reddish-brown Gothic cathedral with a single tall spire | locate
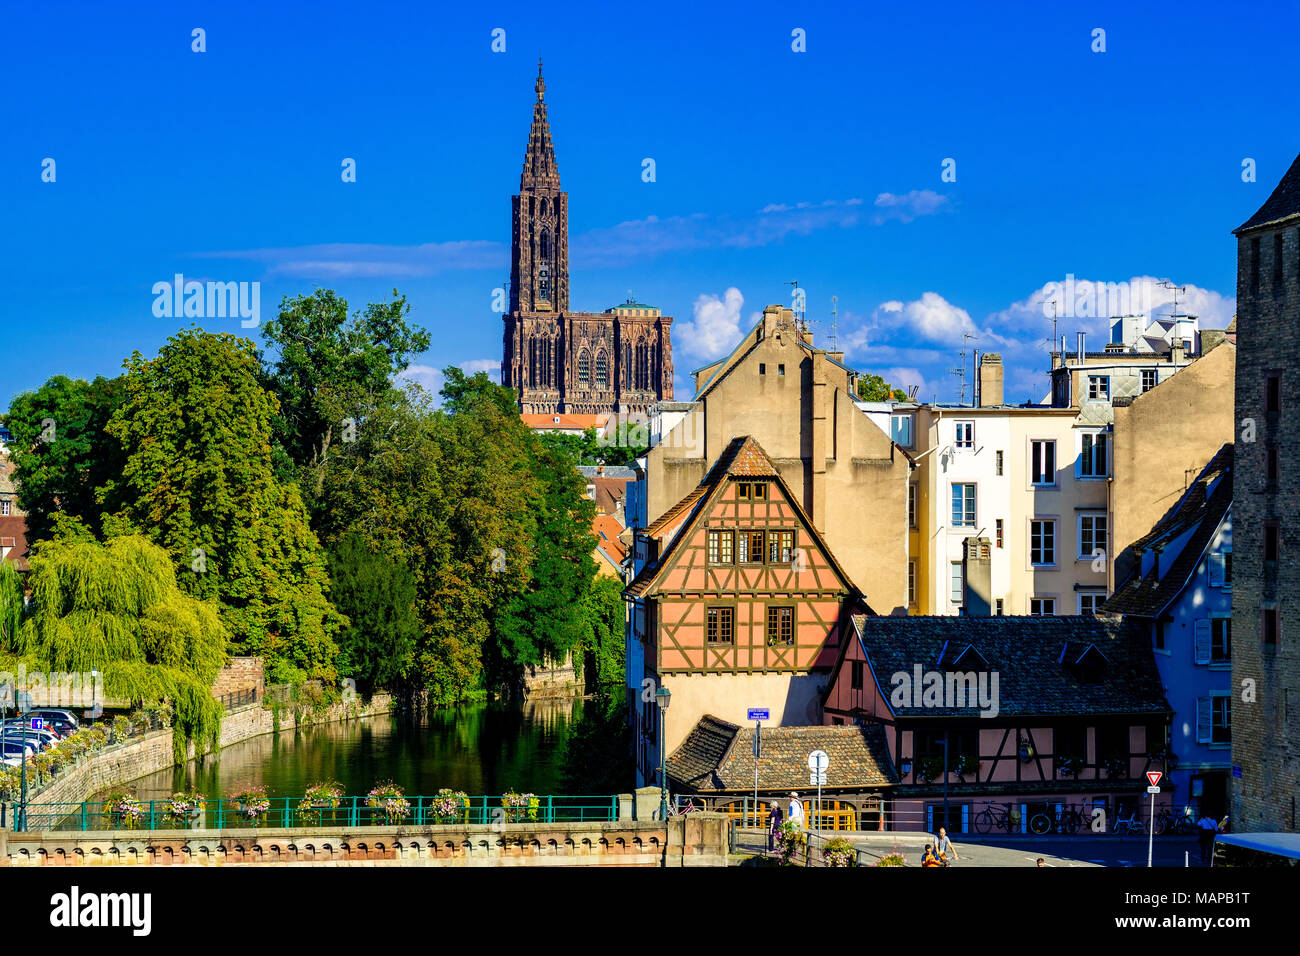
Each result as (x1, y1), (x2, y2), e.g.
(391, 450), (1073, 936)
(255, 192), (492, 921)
(501, 64), (672, 416)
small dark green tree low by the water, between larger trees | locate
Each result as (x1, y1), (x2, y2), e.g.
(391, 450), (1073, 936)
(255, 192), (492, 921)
(329, 532), (420, 696)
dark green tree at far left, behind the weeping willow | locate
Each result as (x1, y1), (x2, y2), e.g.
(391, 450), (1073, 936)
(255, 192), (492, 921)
(5, 375), (124, 544)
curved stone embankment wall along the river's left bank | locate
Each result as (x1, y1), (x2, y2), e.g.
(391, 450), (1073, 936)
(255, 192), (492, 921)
(29, 695), (391, 804)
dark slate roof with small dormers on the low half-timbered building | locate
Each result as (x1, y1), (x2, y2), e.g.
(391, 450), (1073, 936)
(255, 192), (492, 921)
(841, 615), (1170, 718)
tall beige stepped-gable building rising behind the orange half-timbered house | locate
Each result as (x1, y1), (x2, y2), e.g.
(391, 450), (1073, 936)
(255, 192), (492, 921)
(629, 306), (910, 614)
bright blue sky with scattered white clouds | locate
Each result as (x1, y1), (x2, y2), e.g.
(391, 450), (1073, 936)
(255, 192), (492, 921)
(0, 1), (1300, 407)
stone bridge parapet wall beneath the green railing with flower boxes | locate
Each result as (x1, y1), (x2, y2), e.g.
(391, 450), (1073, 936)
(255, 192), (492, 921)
(0, 813), (729, 868)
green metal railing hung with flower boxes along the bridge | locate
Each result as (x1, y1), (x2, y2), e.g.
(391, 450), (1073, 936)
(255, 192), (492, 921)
(10, 795), (619, 831)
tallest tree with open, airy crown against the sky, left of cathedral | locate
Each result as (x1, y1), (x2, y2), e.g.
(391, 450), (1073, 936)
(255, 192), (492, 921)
(263, 289), (429, 499)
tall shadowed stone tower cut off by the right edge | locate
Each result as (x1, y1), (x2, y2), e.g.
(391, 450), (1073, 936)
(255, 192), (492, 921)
(1231, 156), (1300, 831)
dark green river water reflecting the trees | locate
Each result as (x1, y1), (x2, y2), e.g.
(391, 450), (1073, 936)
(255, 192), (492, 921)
(116, 698), (582, 800)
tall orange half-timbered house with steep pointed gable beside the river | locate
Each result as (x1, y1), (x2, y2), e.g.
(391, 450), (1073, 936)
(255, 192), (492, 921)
(624, 437), (862, 782)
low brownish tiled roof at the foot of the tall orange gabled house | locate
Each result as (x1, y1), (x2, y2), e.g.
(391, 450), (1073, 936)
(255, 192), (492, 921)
(668, 714), (898, 793)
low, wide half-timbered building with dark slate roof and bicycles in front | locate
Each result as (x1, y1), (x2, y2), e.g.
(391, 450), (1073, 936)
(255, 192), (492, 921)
(824, 615), (1180, 832)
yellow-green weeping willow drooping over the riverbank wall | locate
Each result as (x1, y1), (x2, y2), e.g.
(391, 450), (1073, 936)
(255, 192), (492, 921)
(0, 535), (228, 762)
